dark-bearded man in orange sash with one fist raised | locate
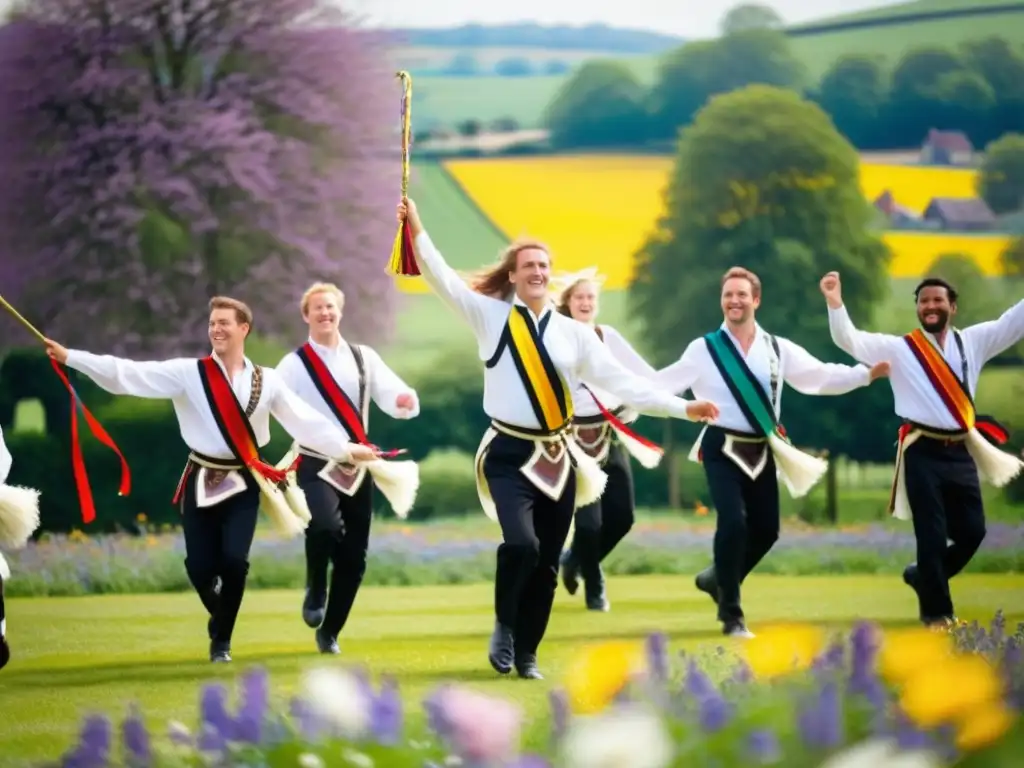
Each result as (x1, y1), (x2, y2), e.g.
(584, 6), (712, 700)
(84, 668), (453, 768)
(821, 272), (1024, 627)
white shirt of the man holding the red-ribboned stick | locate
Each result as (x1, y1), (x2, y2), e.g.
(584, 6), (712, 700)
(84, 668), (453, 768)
(67, 349), (349, 461)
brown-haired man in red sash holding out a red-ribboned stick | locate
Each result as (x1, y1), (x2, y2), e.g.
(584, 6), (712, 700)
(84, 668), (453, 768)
(47, 296), (376, 663)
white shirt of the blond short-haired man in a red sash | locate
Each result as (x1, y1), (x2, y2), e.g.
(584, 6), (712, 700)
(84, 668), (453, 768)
(276, 339), (420, 437)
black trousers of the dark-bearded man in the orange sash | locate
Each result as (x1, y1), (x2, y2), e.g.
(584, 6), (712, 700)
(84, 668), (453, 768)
(903, 436), (985, 621)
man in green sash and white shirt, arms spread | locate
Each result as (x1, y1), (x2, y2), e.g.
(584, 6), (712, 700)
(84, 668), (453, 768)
(657, 267), (888, 638)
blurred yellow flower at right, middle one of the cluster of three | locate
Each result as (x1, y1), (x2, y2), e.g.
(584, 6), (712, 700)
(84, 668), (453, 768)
(900, 655), (1002, 728)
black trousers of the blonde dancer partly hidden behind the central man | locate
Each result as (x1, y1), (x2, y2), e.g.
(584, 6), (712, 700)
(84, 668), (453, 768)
(572, 439), (635, 585)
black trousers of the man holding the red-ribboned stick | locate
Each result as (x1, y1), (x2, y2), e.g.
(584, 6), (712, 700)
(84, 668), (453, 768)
(181, 467), (259, 646)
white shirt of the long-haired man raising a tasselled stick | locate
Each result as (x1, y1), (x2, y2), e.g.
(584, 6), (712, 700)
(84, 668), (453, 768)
(416, 231), (688, 429)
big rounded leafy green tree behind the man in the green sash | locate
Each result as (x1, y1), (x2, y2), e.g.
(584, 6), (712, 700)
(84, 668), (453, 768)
(630, 85), (892, 460)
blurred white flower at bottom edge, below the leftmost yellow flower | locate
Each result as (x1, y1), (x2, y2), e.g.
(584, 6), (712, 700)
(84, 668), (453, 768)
(562, 706), (673, 768)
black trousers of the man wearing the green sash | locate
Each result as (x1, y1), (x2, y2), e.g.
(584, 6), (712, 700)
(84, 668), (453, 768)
(700, 427), (779, 622)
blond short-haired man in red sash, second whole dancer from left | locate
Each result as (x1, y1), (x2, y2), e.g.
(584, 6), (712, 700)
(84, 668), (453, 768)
(278, 283), (420, 653)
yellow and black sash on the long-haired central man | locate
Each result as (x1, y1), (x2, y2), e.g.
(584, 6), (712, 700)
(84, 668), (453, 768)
(485, 304), (572, 432)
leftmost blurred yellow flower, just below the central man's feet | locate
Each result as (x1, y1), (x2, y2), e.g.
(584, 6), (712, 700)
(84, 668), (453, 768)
(565, 640), (644, 715)
